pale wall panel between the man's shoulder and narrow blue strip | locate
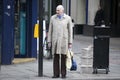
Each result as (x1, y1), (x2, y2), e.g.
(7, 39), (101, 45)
(71, 0), (86, 24)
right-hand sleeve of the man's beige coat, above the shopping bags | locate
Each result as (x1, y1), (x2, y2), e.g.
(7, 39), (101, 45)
(68, 17), (73, 43)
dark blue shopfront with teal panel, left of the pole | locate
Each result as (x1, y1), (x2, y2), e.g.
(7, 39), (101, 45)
(0, 0), (37, 64)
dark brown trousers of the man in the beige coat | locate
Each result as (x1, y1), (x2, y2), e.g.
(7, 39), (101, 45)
(53, 54), (66, 76)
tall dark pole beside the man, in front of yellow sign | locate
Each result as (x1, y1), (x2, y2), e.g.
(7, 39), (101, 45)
(38, 0), (44, 77)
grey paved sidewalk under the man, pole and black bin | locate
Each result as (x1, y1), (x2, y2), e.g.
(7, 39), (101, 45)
(0, 35), (120, 80)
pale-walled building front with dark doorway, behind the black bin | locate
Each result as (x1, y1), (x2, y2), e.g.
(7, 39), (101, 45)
(71, 0), (120, 37)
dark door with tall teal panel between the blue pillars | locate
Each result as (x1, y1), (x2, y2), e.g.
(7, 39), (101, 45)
(14, 0), (27, 57)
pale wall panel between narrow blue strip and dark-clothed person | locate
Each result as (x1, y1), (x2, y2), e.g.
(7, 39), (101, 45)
(88, 0), (99, 25)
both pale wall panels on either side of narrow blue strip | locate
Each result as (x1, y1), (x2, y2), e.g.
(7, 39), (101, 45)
(71, 0), (100, 25)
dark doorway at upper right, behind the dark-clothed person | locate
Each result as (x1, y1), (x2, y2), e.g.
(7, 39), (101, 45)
(100, 0), (120, 37)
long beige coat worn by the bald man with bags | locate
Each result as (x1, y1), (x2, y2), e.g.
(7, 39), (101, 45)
(48, 14), (73, 54)
